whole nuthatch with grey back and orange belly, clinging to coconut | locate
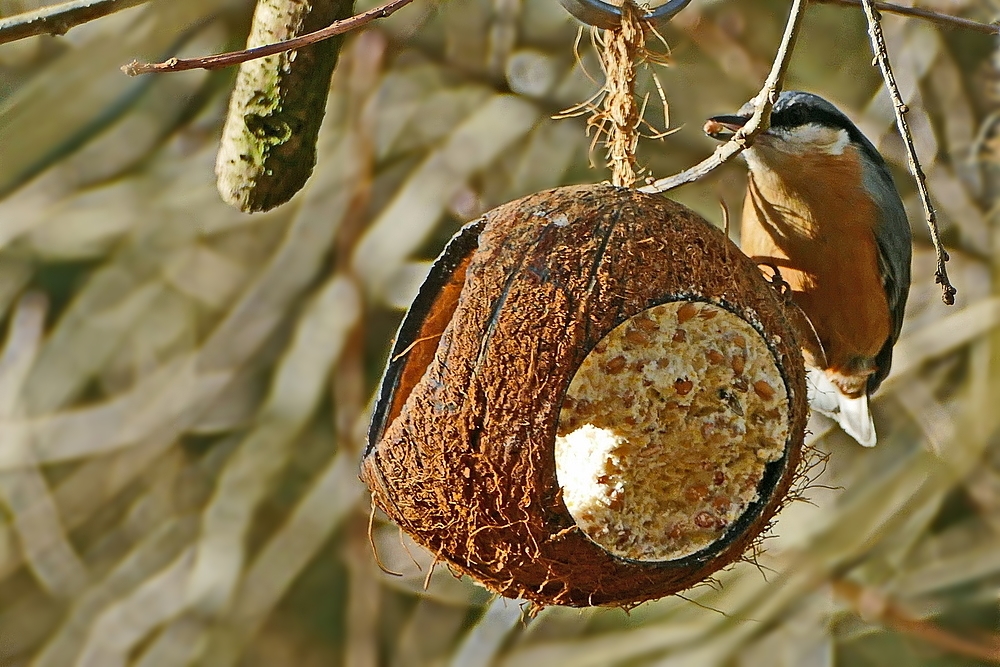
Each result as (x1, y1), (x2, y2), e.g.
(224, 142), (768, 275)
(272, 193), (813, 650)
(705, 91), (911, 447)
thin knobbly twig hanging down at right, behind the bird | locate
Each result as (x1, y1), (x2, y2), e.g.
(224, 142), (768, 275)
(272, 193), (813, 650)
(861, 0), (957, 306)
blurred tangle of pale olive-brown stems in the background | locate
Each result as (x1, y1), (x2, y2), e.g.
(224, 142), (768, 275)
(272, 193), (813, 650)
(0, 0), (1000, 667)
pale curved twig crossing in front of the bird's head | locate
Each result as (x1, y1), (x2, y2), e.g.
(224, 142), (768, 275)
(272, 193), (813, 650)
(639, 0), (808, 192)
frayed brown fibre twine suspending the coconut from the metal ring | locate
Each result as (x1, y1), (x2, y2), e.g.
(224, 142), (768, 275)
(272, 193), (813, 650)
(601, 0), (645, 188)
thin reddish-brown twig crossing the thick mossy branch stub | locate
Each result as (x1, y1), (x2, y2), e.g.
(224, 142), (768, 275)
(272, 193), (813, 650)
(122, 0), (412, 76)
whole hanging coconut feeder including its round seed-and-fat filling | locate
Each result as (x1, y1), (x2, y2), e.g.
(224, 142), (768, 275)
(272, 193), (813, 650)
(361, 184), (808, 606)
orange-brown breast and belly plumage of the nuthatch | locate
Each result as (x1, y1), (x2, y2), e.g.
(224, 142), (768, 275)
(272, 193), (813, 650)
(740, 147), (891, 396)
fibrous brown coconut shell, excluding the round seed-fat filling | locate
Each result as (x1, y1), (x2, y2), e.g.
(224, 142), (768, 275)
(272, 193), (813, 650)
(361, 185), (808, 606)
